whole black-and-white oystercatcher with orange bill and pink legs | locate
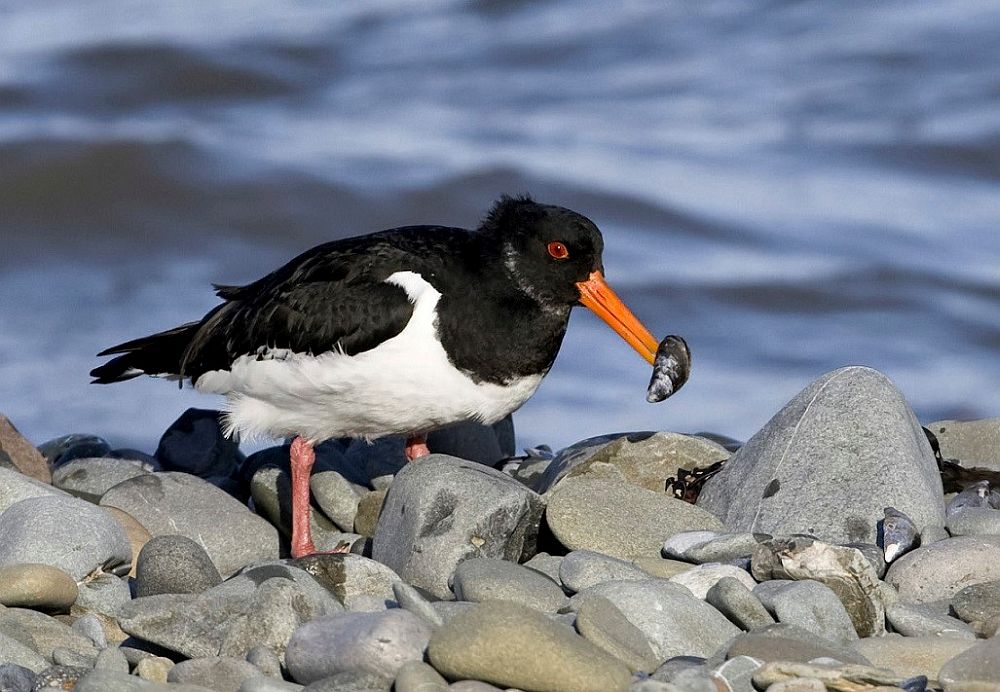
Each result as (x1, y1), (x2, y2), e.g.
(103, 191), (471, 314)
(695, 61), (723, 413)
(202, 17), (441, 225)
(91, 196), (657, 557)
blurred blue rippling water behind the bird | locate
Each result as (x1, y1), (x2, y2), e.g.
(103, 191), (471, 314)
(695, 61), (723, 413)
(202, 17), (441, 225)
(0, 0), (1000, 449)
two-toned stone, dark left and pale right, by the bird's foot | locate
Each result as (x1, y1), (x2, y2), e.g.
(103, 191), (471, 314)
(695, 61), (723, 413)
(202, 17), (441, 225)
(289, 553), (402, 610)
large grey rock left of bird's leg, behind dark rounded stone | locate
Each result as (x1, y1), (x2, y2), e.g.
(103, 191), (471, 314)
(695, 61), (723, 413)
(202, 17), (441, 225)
(101, 472), (279, 577)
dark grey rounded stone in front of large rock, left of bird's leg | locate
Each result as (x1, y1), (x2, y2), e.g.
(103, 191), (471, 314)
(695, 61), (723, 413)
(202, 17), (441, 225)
(135, 535), (222, 597)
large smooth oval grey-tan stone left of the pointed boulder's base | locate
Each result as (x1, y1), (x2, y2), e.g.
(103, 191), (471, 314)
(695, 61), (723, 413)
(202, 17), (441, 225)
(545, 476), (723, 560)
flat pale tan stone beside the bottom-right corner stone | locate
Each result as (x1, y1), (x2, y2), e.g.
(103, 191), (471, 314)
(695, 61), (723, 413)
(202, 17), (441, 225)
(851, 634), (975, 680)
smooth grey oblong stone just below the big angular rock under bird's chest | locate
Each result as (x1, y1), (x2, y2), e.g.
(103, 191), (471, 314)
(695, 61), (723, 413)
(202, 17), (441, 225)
(452, 557), (566, 613)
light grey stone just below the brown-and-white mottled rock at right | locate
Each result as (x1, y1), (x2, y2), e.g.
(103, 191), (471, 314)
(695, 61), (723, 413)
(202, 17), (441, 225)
(755, 580), (858, 644)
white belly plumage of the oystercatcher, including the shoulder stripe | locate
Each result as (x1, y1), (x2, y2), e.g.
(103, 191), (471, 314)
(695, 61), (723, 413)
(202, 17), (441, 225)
(196, 271), (542, 442)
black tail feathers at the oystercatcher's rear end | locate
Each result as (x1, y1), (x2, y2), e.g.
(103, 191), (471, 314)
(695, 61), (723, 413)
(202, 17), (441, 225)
(90, 322), (200, 384)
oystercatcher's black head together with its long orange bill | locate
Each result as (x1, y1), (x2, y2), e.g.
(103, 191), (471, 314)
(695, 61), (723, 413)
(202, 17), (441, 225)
(480, 196), (658, 364)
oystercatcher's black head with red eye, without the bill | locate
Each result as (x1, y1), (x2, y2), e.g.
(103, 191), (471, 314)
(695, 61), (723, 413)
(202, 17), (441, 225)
(483, 196), (604, 310)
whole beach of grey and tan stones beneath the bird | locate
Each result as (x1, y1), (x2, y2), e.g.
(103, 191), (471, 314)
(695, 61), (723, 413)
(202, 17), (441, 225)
(0, 367), (1000, 692)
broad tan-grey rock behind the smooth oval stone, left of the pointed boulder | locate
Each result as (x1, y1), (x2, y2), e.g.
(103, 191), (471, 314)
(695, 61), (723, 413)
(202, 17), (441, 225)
(535, 432), (729, 492)
